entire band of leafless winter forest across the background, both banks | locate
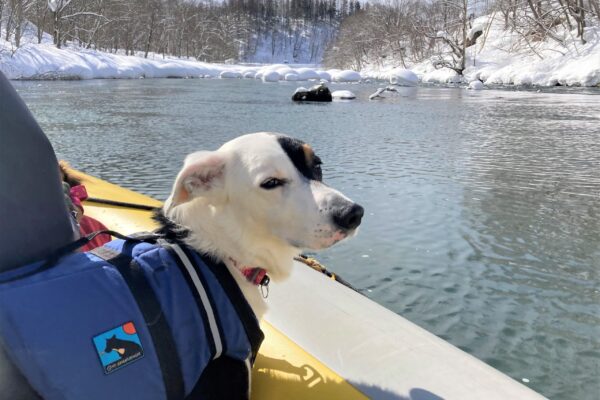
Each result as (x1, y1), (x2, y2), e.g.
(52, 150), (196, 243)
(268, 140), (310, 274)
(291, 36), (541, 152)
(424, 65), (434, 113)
(0, 0), (600, 74)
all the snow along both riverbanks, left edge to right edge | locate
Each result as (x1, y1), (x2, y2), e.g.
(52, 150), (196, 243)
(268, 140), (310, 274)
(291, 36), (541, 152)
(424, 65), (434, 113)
(0, 16), (600, 86)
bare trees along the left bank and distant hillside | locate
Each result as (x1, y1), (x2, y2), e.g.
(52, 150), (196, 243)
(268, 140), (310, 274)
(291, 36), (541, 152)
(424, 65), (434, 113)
(0, 0), (360, 62)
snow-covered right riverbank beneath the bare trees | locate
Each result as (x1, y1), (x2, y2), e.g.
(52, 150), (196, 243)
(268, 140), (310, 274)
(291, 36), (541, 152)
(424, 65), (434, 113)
(363, 14), (600, 86)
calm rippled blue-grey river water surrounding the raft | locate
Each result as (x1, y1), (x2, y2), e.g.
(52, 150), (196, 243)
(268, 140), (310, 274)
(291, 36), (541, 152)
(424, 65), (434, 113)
(10, 80), (600, 400)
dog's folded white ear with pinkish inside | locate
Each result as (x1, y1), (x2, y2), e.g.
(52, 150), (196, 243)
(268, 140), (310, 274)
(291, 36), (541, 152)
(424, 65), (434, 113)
(165, 151), (225, 209)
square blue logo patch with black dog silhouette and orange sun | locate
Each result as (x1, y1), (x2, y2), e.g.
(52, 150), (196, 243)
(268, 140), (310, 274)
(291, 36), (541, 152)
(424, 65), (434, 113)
(93, 322), (144, 374)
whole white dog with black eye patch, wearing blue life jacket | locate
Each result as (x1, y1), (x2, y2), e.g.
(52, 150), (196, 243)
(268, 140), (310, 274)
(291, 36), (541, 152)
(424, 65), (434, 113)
(0, 132), (364, 400)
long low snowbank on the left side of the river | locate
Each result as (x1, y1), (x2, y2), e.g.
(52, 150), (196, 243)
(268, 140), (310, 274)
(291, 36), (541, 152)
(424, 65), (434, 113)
(0, 40), (361, 82)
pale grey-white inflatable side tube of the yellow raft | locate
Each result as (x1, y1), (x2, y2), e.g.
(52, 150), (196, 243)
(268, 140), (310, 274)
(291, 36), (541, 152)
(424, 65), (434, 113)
(264, 261), (545, 400)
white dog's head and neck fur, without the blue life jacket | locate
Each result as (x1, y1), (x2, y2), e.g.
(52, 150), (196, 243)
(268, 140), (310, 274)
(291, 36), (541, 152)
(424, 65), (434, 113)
(162, 132), (364, 319)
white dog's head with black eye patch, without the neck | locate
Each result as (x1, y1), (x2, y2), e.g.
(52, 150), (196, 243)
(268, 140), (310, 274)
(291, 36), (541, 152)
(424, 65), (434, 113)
(165, 132), (363, 276)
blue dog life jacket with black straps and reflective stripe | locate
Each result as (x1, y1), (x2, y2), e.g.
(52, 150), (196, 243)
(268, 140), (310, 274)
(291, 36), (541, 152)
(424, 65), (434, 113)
(0, 234), (264, 400)
